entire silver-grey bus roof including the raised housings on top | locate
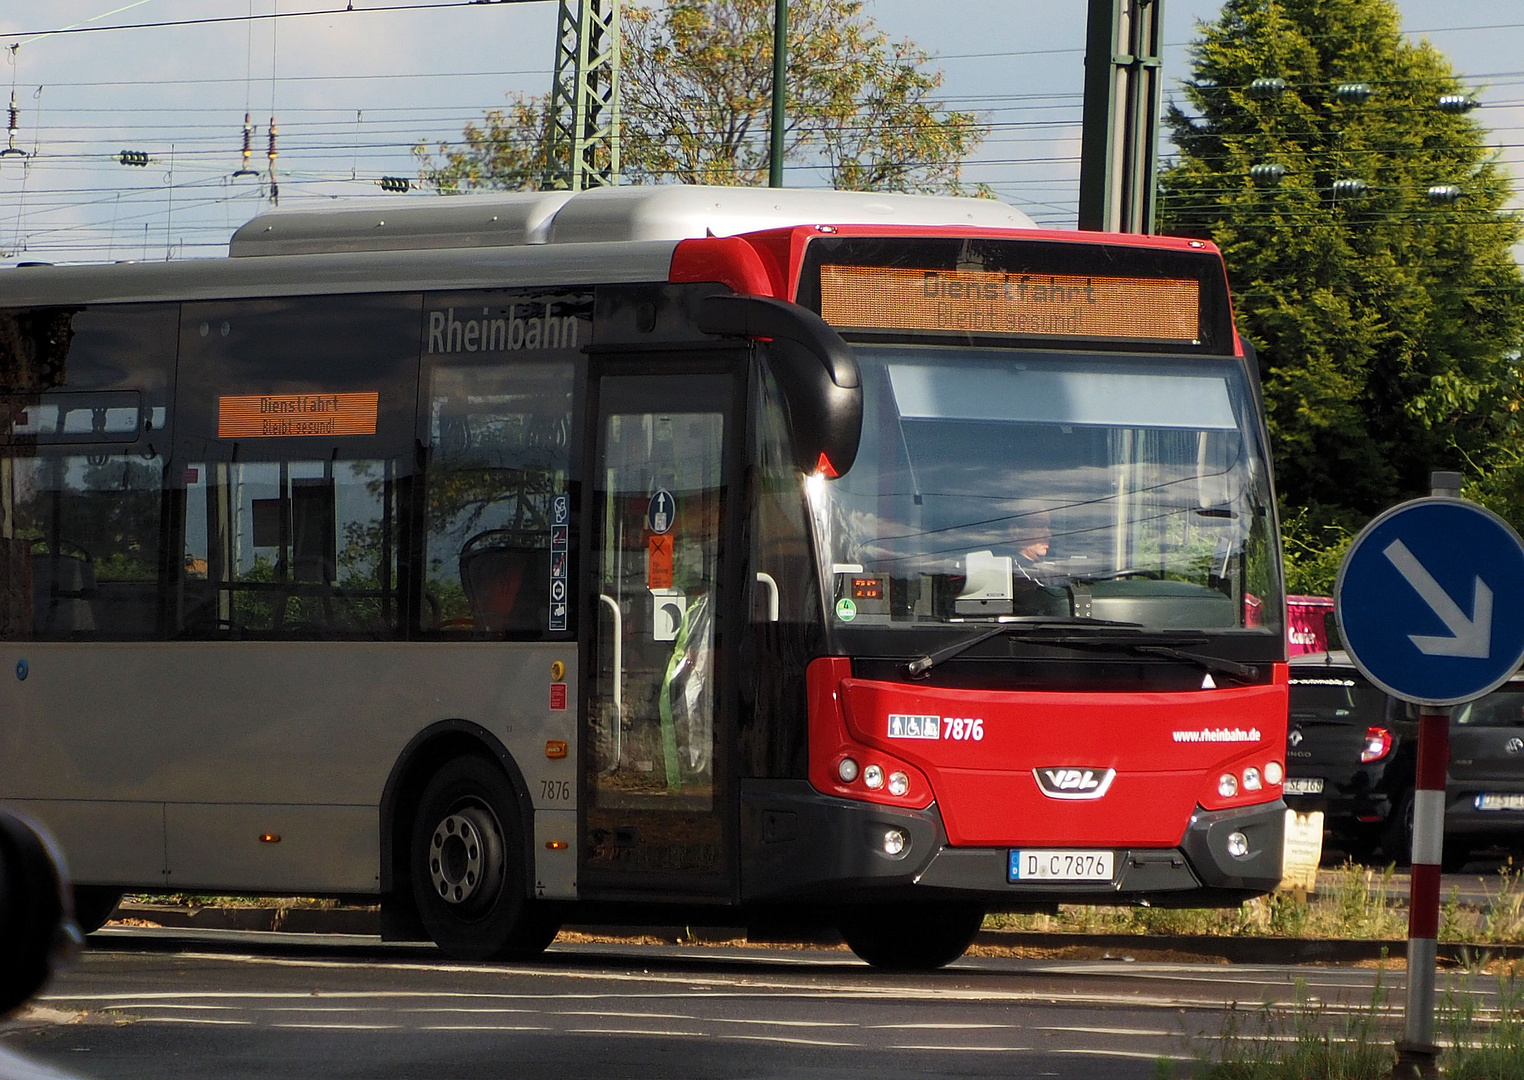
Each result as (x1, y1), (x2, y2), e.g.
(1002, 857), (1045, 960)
(0, 184), (1035, 308)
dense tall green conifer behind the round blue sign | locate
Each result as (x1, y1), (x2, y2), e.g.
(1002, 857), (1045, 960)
(1160, 0), (1524, 539)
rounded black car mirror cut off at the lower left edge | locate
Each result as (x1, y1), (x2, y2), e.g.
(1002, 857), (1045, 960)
(0, 809), (82, 1016)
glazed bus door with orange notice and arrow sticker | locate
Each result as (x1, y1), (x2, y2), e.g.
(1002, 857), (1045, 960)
(581, 367), (739, 900)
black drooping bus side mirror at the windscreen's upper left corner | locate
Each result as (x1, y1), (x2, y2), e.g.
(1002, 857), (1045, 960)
(698, 294), (863, 475)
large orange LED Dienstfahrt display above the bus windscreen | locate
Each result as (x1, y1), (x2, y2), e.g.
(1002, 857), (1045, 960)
(820, 265), (1201, 343)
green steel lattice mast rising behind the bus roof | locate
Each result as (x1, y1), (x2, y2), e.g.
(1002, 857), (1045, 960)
(544, 0), (619, 192)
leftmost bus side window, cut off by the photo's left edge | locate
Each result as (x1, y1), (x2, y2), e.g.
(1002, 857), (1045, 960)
(0, 305), (175, 640)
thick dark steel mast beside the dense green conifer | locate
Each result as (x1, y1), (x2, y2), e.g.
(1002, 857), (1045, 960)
(1079, 0), (1164, 233)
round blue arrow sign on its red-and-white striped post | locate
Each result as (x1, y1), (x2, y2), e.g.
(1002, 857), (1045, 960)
(1334, 472), (1524, 1078)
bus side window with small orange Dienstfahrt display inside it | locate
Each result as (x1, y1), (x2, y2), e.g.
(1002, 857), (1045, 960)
(169, 294), (422, 640)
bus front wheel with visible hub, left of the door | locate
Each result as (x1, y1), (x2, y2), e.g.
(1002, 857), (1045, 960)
(408, 757), (559, 960)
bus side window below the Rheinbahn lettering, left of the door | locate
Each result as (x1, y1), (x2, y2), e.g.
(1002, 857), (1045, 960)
(421, 358), (575, 638)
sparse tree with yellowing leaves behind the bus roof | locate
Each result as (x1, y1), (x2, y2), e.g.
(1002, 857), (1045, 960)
(415, 0), (985, 192)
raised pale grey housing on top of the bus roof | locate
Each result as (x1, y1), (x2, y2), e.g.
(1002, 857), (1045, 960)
(229, 184), (1035, 256)
